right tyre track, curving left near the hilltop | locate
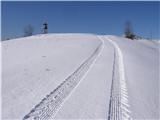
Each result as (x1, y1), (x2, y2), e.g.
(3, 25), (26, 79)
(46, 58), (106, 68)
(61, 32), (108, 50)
(105, 37), (132, 120)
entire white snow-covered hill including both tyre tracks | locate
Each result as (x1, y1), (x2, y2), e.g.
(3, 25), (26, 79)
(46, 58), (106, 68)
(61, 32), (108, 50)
(1, 33), (160, 120)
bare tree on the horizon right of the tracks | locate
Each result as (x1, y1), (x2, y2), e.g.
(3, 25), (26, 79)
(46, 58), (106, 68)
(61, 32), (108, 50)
(124, 21), (135, 40)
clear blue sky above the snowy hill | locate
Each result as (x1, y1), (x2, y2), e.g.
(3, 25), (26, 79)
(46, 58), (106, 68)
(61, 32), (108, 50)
(1, 1), (160, 38)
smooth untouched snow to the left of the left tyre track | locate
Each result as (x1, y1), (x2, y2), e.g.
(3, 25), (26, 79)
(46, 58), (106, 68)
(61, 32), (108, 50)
(2, 34), (101, 119)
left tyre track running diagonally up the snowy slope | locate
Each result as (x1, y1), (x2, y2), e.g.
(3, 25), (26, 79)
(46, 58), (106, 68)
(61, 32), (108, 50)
(23, 39), (104, 120)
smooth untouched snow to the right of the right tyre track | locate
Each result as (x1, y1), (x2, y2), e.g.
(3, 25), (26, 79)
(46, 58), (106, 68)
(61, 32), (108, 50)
(106, 36), (159, 120)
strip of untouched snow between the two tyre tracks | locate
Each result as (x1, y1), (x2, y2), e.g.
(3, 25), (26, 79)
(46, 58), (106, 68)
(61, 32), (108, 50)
(54, 37), (113, 119)
